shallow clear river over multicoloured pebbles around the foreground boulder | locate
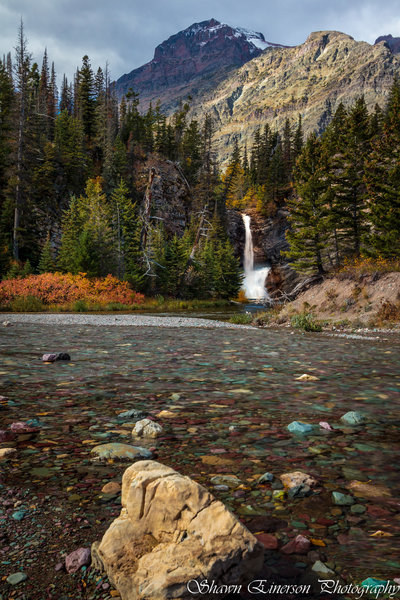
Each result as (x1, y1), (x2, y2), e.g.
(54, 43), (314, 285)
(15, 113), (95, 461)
(0, 315), (400, 600)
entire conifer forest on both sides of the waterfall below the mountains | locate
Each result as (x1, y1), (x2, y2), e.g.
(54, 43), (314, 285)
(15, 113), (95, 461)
(0, 23), (400, 298)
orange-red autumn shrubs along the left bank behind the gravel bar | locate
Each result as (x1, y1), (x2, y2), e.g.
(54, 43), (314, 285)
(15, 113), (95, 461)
(0, 273), (144, 307)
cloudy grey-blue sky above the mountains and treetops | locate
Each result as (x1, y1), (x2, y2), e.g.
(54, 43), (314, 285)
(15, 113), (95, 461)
(0, 0), (400, 79)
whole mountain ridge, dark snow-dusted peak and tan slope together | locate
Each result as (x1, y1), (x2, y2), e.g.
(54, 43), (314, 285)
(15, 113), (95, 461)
(116, 19), (400, 164)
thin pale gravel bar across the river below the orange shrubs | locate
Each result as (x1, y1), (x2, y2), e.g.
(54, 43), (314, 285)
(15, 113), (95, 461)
(0, 313), (254, 329)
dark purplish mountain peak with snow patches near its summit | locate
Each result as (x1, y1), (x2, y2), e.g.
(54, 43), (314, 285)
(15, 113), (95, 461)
(116, 19), (288, 110)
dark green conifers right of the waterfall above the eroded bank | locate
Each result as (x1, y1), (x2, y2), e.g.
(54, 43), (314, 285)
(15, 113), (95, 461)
(287, 86), (400, 274)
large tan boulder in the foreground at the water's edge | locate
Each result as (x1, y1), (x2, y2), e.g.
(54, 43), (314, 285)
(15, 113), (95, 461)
(98, 460), (263, 600)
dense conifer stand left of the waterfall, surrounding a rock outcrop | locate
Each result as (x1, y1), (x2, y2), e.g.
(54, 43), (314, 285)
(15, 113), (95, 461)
(0, 23), (241, 297)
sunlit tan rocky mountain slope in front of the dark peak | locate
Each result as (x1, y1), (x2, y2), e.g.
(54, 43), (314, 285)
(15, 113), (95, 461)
(193, 31), (400, 162)
